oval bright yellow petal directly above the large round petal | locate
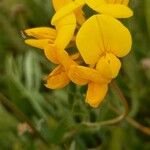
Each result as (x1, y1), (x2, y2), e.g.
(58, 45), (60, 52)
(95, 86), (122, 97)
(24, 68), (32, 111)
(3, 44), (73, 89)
(94, 4), (133, 18)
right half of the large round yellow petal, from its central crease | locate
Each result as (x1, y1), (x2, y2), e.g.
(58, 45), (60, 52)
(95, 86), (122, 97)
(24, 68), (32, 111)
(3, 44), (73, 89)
(97, 15), (132, 57)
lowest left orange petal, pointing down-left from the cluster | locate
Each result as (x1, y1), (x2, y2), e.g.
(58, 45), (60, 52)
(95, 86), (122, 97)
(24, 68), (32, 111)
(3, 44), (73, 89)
(45, 66), (70, 89)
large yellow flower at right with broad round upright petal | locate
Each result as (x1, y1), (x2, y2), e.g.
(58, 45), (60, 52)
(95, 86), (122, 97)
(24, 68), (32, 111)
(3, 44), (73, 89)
(69, 15), (132, 107)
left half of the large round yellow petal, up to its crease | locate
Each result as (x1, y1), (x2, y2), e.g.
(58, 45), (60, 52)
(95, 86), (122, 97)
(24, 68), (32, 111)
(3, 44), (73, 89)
(76, 15), (105, 64)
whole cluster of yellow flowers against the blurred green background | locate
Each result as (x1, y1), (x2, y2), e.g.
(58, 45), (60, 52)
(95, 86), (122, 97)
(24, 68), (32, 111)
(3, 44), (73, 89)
(25, 0), (133, 107)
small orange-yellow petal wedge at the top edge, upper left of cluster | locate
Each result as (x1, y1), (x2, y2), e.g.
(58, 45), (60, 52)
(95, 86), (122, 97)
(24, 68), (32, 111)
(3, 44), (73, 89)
(52, 0), (72, 11)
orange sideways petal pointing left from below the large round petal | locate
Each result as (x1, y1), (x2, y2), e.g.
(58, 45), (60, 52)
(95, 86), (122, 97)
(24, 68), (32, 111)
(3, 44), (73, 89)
(68, 65), (110, 84)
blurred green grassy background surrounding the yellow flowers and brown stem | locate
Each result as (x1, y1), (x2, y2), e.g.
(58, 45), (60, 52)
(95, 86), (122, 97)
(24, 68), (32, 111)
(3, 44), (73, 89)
(0, 0), (150, 150)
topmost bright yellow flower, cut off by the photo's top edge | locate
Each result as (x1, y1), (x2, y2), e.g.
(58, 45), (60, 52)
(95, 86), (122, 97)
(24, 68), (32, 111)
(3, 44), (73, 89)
(52, 0), (133, 24)
